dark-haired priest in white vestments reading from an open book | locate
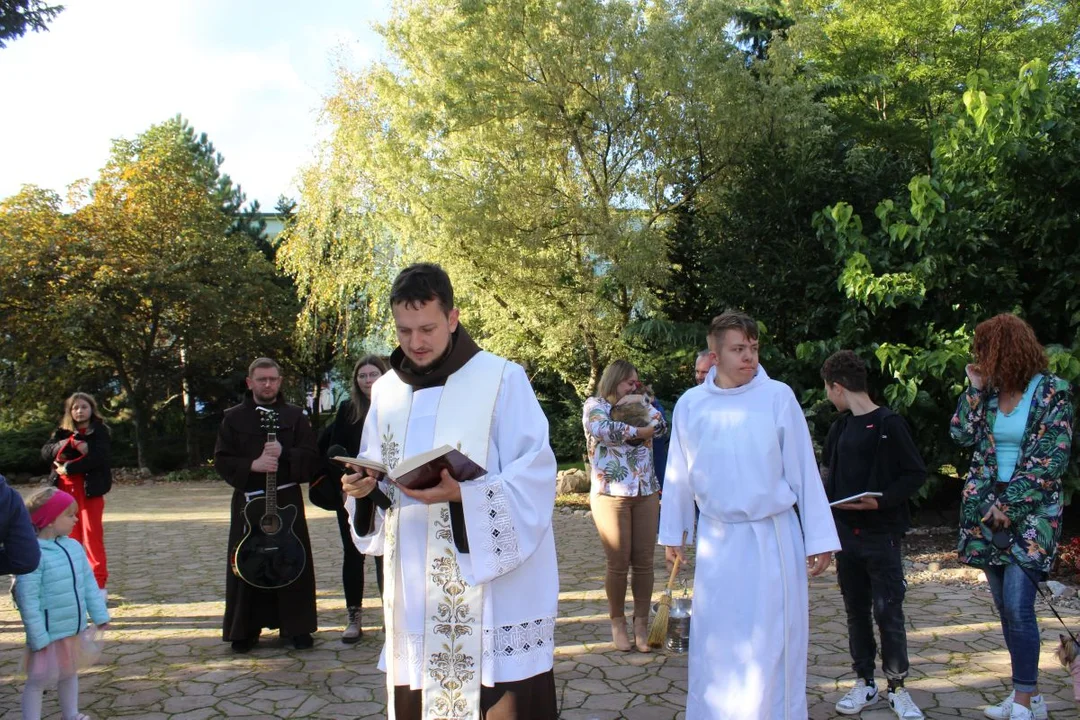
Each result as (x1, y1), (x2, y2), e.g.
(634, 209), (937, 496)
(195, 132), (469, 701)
(342, 263), (558, 720)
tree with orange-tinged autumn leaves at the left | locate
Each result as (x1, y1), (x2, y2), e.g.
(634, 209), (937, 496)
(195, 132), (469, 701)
(0, 118), (291, 466)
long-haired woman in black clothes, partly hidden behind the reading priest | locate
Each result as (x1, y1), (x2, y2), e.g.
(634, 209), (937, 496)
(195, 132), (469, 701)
(327, 355), (387, 644)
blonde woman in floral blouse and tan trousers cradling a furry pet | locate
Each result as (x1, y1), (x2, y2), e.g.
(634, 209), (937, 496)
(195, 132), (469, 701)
(582, 359), (667, 652)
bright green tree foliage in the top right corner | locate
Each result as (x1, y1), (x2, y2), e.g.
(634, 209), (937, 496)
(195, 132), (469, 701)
(792, 0), (1080, 165)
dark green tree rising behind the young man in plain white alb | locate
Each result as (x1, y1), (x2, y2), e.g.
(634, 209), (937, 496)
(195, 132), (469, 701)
(631, 38), (851, 405)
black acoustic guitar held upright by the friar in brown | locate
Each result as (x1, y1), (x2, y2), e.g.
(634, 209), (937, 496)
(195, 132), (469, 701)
(232, 406), (308, 589)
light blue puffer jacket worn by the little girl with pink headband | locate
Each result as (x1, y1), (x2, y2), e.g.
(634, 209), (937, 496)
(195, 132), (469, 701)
(13, 538), (109, 651)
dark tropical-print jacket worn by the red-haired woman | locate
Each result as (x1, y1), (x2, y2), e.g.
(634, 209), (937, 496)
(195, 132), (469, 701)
(949, 373), (1072, 572)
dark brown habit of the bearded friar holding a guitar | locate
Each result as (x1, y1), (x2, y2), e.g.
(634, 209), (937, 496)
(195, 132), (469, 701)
(214, 393), (319, 640)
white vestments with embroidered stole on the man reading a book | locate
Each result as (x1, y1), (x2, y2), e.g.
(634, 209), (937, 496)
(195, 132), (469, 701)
(347, 352), (558, 719)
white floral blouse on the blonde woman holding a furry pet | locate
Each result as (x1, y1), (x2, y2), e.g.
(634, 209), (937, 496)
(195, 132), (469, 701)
(582, 397), (667, 498)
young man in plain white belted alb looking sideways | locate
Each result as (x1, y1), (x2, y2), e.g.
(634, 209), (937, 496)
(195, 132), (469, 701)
(660, 311), (840, 720)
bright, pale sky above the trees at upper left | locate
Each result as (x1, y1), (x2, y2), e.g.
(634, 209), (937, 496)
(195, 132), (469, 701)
(0, 0), (390, 210)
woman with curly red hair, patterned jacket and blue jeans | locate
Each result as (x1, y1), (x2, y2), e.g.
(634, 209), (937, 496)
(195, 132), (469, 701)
(950, 314), (1072, 720)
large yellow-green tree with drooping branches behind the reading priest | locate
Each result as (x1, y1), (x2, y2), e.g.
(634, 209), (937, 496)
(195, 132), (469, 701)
(284, 0), (756, 392)
